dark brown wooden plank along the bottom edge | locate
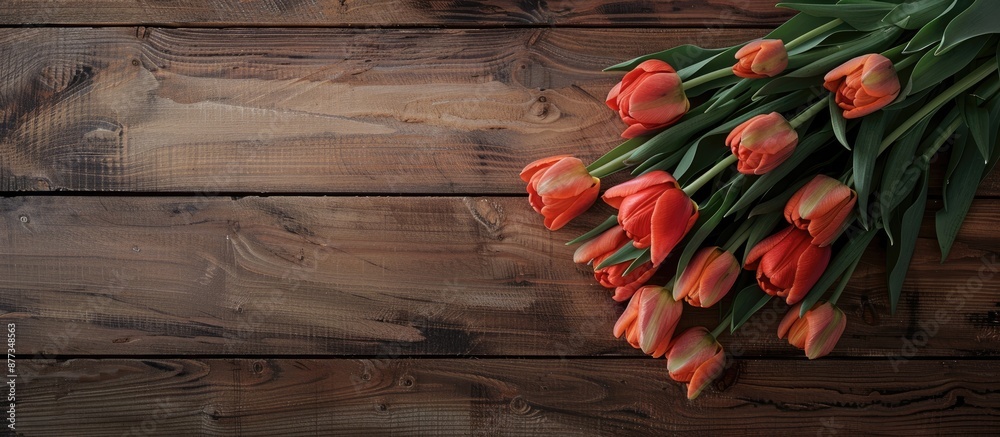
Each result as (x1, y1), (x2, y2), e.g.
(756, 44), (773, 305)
(9, 358), (1000, 436)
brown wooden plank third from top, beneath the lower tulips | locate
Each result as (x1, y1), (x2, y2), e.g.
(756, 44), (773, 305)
(0, 196), (1000, 360)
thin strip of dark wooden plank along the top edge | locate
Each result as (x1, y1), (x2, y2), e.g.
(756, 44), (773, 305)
(0, 0), (791, 28)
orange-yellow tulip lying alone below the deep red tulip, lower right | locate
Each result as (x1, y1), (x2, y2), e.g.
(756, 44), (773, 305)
(778, 302), (847, 360)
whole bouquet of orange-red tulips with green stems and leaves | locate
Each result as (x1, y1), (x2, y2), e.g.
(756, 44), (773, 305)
(521, 0), (1000, 398)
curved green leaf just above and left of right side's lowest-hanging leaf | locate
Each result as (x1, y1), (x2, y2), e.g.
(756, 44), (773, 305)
(878, 112), (932, 244)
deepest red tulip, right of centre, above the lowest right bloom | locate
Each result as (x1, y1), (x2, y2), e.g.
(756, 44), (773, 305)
(744, 226), (830, 305)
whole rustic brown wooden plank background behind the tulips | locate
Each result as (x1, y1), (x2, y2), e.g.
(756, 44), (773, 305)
(0, 0), (1000, 436)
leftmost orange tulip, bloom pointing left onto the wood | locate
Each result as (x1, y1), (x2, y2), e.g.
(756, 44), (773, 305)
(521, 156), (601, 231)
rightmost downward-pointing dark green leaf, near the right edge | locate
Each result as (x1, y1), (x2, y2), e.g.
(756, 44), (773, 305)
(934, 124), (986, 262)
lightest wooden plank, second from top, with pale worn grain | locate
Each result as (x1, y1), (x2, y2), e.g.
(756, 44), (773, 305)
(0, 26), (764, 194)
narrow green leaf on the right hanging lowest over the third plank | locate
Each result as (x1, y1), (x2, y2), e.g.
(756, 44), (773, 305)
(886, 171), (930, 314)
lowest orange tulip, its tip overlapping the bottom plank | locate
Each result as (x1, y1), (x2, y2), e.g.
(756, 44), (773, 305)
(667, 326), (726, 399)
